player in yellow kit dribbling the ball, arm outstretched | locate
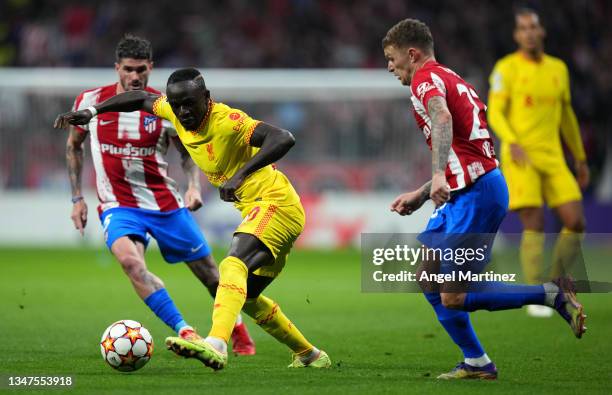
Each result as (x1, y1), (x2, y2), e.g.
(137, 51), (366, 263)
(55, 68), (331, 370)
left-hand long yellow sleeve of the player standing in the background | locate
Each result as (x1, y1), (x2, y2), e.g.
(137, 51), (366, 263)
(487, 61), (517, 144)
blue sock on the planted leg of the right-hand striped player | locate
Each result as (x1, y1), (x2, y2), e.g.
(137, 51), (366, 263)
(424, 293), (485, 358)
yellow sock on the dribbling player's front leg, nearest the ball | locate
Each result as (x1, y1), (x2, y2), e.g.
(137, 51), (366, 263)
(208, 256), (249, 343)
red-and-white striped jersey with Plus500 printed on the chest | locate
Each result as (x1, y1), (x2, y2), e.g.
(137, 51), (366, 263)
(73, 84), (183, 213)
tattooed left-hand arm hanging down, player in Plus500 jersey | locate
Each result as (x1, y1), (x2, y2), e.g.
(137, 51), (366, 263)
(66, 127), (87, 236)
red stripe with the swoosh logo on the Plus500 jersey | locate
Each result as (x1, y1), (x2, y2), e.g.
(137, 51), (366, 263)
(98, 85), (138, 207)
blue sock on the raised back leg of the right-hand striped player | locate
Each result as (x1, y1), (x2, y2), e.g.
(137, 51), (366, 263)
(463, 281), (546, 311)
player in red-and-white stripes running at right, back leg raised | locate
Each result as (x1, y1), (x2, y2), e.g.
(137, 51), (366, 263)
(382, 19), (586, 380)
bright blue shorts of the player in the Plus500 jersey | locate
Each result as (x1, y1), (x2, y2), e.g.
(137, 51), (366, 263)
(100, 207), (211, 263)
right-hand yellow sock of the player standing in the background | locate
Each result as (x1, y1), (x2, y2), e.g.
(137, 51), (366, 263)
(551, 228), (586, 280)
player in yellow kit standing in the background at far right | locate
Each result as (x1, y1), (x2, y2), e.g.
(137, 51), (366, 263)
(487, 9), (589, 316)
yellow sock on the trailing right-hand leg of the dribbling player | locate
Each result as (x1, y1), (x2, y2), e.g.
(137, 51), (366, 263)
(241, 293), (314, 356)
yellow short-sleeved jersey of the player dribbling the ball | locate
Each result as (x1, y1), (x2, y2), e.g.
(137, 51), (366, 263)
(153, 95), (300, 210)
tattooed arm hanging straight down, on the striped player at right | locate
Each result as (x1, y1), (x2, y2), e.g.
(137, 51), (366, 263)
(427, 96), (453, 206)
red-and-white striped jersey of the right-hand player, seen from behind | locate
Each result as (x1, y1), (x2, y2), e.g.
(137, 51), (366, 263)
(410, 61), (498, 191)
